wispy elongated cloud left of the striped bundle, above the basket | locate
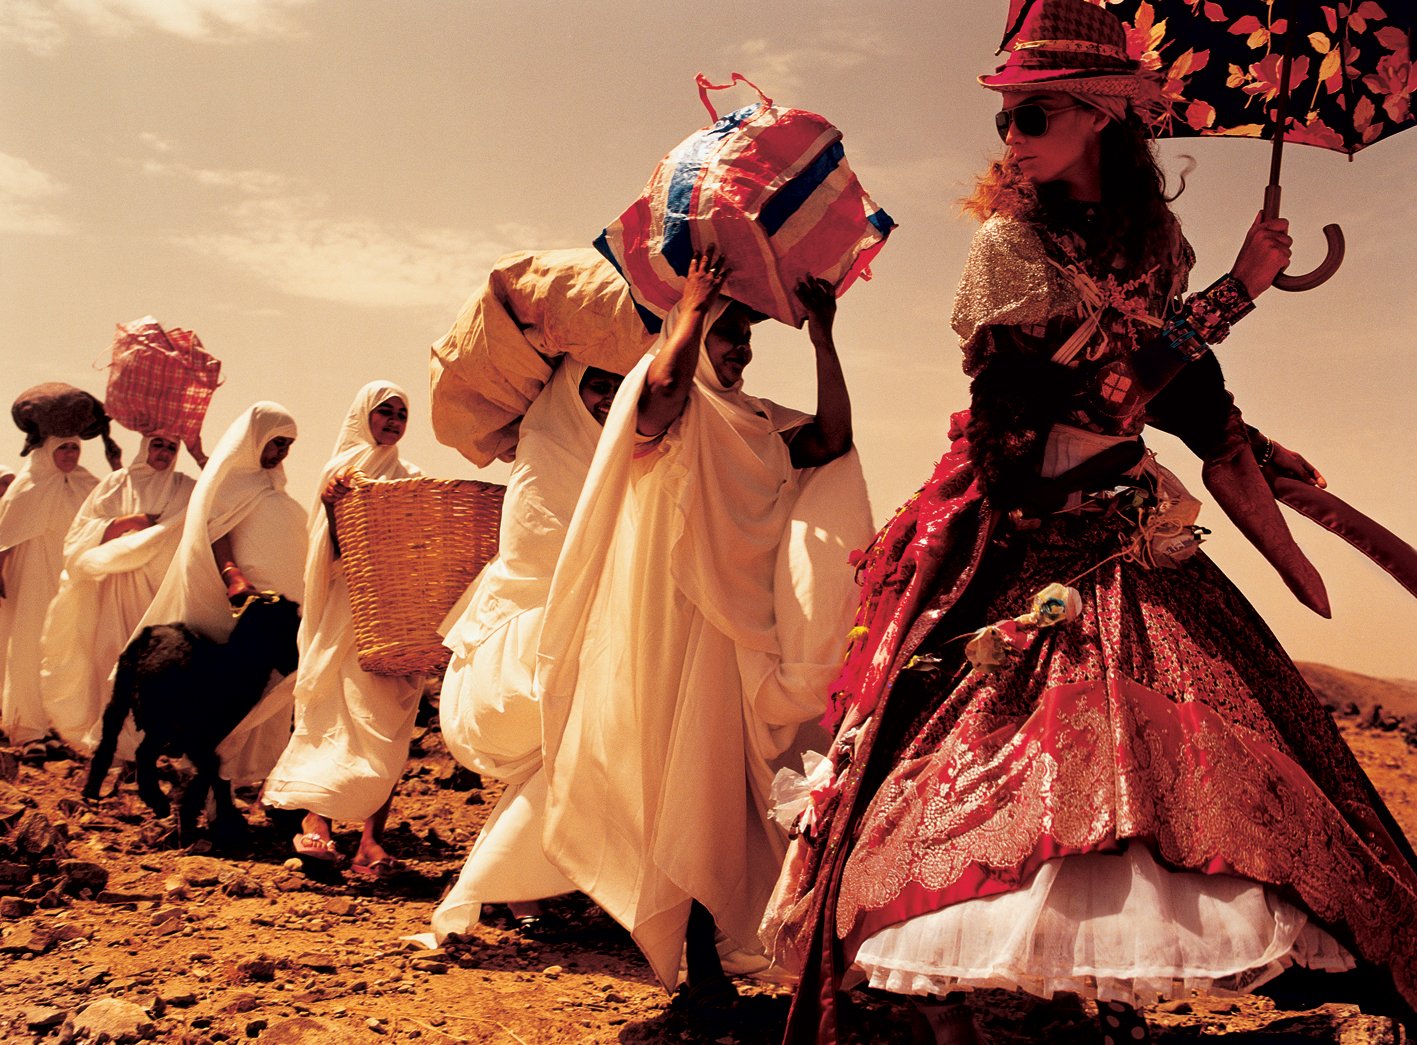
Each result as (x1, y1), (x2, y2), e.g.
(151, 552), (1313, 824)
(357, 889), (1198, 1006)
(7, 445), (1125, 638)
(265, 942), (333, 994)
(174, 196), (534, 309)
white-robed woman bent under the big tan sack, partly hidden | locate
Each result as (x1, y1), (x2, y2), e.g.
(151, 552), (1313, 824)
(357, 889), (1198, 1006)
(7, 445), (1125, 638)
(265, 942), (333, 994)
(432, 357), (623, 941)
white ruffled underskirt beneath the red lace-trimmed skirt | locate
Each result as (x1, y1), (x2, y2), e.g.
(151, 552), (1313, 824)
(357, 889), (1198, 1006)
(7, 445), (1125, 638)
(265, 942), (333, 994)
(854, 844), (1353, 1005)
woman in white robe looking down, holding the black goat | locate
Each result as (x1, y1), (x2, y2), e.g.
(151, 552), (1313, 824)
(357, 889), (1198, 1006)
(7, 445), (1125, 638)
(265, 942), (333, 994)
(135, 403), (305, 784)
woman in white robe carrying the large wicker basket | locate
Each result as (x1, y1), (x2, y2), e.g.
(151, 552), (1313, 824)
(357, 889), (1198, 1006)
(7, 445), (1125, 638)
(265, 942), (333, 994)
(262, 381), (422, 878)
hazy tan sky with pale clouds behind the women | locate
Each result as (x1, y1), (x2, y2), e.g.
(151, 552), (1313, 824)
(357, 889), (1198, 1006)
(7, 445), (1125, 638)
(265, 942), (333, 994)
(0, 0), (1417, 679)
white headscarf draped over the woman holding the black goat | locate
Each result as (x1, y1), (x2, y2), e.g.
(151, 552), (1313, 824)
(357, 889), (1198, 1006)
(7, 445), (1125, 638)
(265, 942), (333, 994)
(135, 403), (305, 641)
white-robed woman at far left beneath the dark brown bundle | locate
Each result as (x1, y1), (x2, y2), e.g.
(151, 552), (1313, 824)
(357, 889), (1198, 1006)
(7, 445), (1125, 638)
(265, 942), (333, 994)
(0, 435), (98, 744)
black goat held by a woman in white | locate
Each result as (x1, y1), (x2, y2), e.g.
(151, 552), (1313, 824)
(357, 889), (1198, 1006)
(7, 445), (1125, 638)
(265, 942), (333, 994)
(84, 593), (300, 842)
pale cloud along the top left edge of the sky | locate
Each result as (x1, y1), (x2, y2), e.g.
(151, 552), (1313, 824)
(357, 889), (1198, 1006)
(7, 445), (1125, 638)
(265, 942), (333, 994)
(0, 0), (309, 57)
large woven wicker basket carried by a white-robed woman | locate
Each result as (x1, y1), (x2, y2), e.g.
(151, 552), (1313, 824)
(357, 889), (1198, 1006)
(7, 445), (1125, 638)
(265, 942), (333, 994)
(334, 478), (507, 675)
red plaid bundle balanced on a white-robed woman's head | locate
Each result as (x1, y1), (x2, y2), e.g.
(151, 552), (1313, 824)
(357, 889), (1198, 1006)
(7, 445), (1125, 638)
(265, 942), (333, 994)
(103, 316), (221, 442)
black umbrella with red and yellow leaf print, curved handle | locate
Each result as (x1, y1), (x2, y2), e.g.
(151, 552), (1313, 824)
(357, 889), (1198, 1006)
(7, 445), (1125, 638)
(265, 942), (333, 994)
(1005, 0), (1417, 289)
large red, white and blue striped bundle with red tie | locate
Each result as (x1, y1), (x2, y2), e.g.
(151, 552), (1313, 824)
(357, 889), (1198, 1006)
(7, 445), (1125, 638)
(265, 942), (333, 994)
(595, 72), (896, 333)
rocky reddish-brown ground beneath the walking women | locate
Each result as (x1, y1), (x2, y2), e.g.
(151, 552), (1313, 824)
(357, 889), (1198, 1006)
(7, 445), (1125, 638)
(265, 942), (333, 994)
(0, 689), (1417, 1045)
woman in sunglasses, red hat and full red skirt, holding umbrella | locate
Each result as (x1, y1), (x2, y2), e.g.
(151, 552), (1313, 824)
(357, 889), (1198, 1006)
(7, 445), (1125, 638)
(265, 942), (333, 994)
(764, 0), (1417, 1042)
